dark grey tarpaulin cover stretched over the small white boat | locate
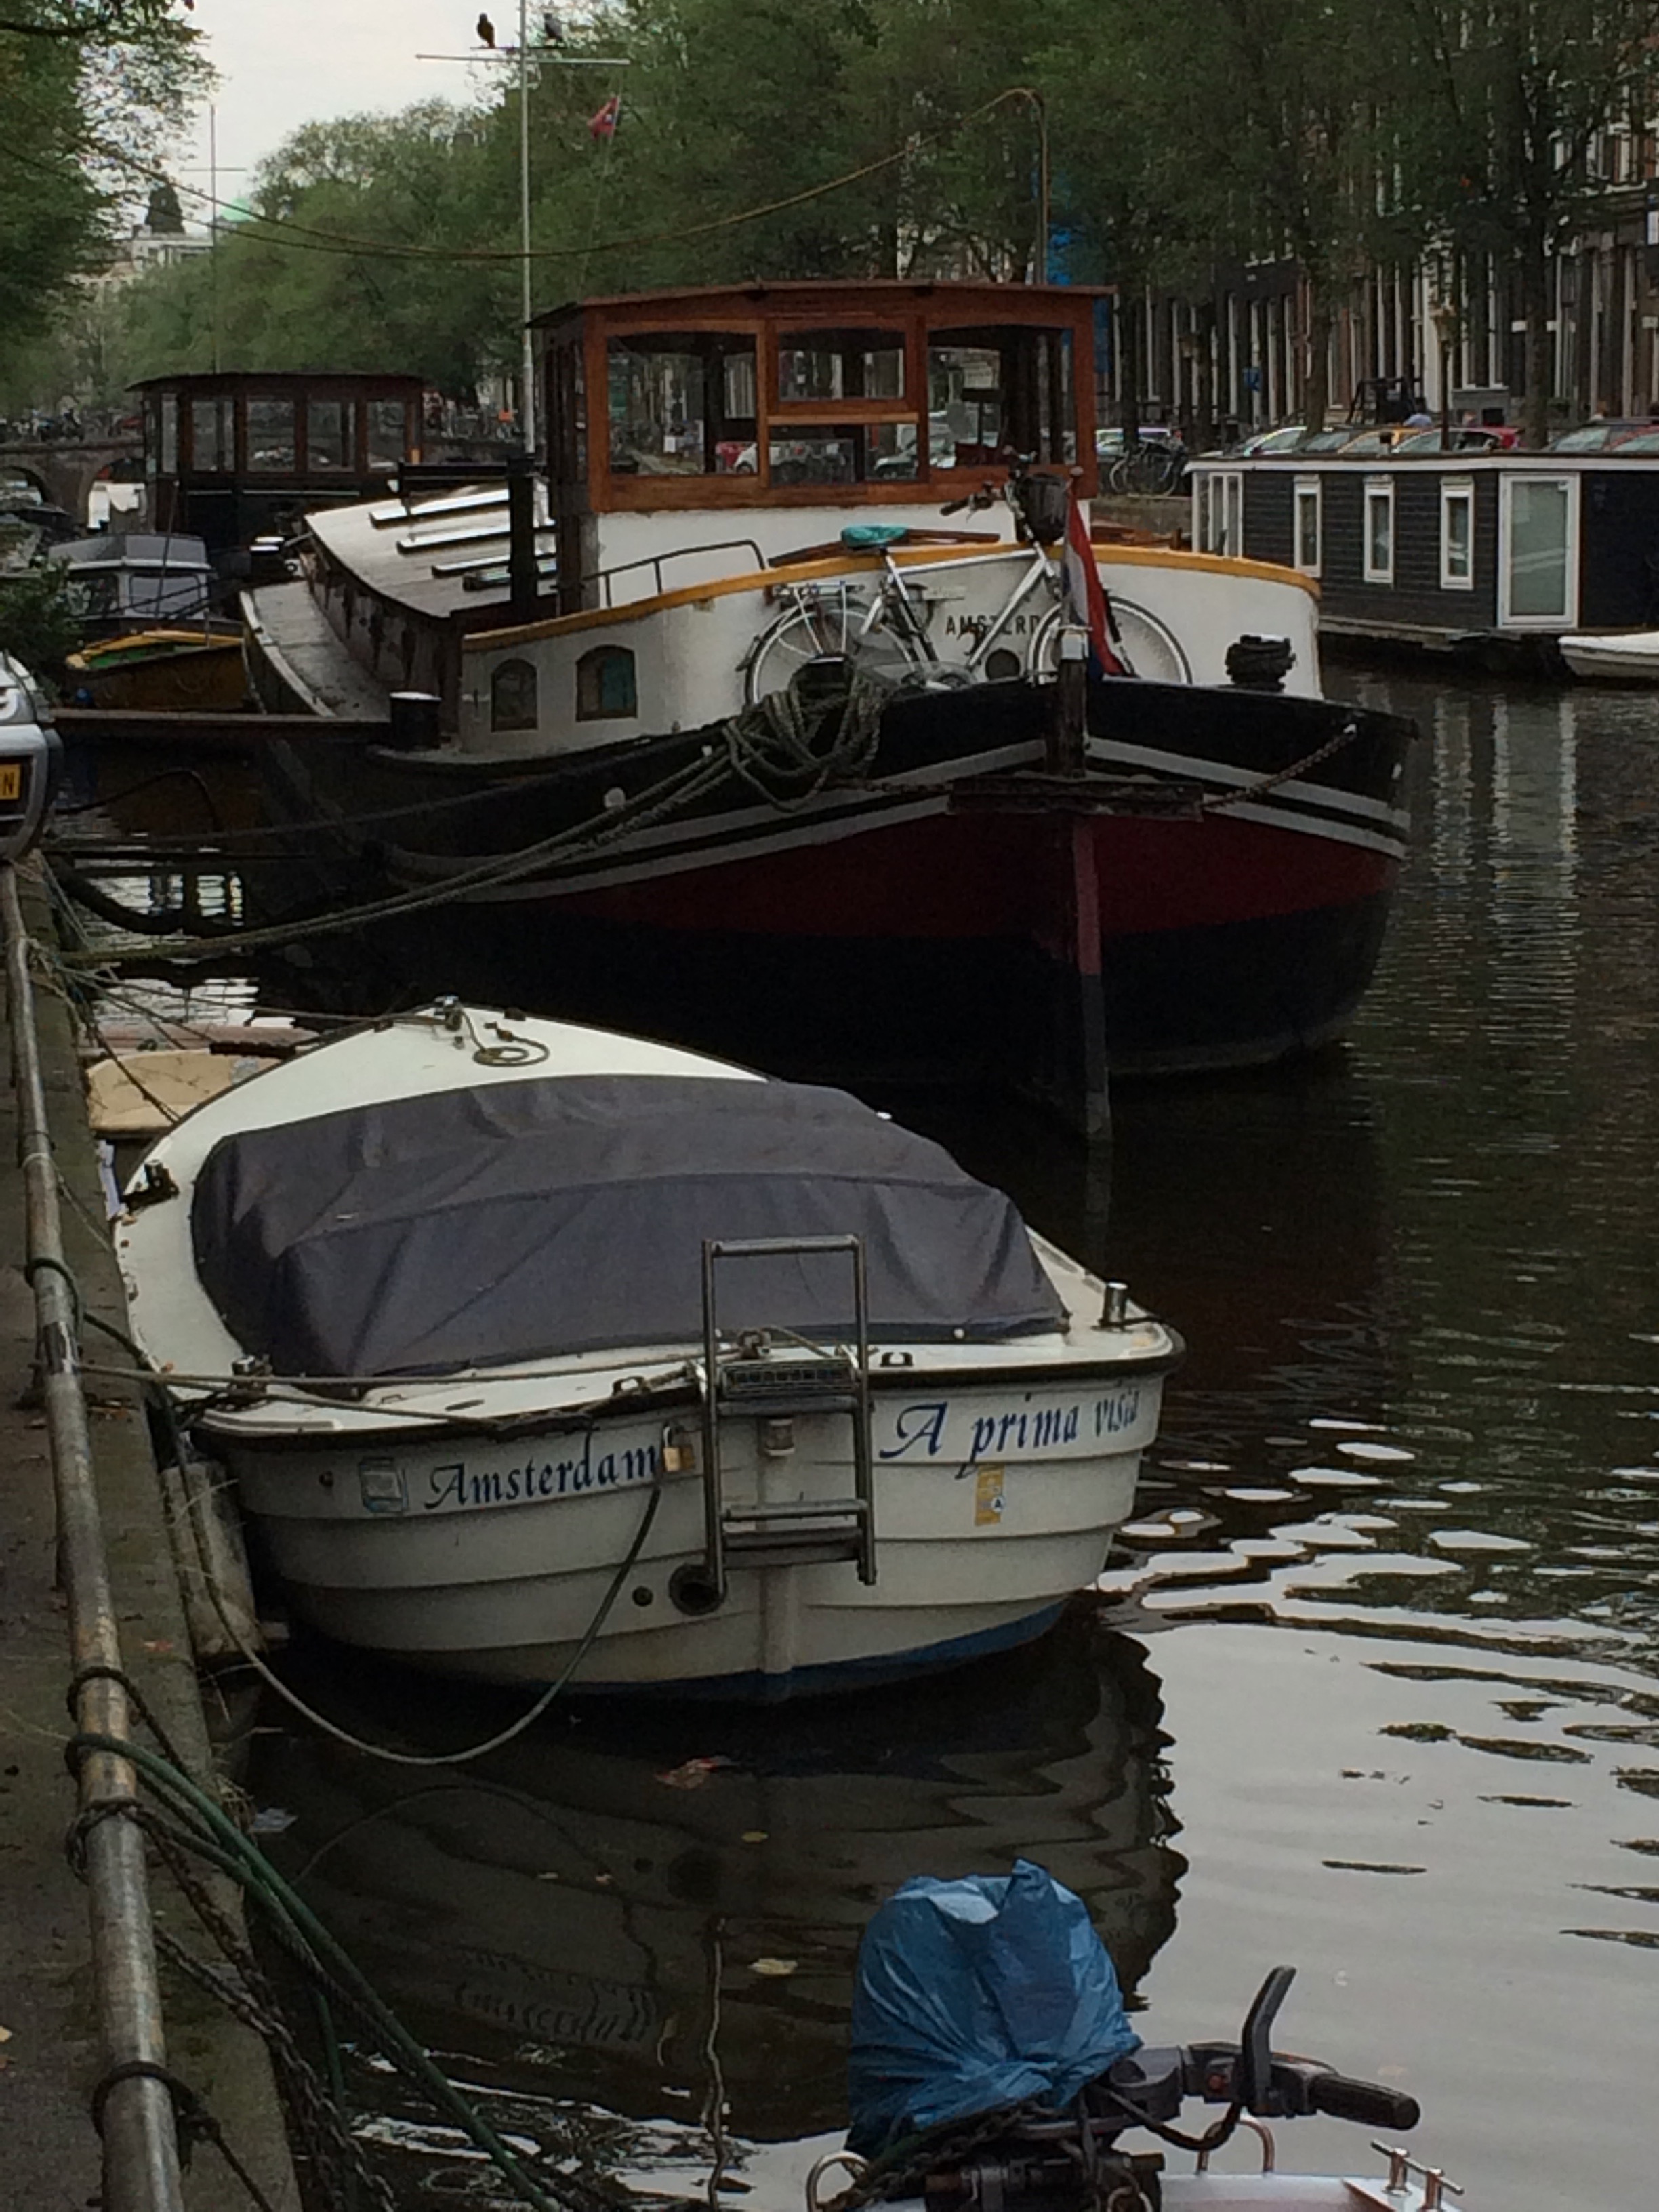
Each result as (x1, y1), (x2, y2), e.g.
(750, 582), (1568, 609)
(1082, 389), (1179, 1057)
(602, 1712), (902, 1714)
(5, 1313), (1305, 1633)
(190, 1075), (1062, 1376)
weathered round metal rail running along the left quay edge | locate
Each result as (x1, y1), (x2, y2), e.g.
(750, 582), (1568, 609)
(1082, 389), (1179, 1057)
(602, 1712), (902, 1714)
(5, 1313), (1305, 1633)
(0, 865), (184, 2212)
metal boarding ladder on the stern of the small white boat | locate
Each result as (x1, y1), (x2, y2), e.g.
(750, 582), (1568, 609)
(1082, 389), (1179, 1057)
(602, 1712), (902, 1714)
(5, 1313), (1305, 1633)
(701, 1237), (876, 1610)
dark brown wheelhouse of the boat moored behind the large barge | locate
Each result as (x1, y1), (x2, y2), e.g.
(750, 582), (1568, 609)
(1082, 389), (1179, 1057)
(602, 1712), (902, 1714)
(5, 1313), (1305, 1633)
(133, 371), (422, 553)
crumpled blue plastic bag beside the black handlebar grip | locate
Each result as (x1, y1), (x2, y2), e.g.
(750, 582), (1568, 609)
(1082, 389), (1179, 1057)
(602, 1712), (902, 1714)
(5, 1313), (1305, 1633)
(847, 1858), (1139, 2156)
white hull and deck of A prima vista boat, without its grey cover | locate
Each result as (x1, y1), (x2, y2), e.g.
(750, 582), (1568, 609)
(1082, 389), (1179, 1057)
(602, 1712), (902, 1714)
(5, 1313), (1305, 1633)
(117, 1013), (1181, 1699)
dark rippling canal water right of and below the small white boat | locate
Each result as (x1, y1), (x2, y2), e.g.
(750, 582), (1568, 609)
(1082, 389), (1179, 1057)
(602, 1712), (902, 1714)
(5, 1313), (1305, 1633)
(71, 668), (1659, 2212)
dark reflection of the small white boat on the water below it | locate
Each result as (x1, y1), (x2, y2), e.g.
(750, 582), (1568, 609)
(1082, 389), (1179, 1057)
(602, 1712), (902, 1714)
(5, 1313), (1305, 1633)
(259, 1608), (1183, 2194)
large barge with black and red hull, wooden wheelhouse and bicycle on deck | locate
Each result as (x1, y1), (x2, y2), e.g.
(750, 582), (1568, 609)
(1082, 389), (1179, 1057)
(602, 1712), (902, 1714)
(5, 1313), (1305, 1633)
(245, 281), (1411, 1128)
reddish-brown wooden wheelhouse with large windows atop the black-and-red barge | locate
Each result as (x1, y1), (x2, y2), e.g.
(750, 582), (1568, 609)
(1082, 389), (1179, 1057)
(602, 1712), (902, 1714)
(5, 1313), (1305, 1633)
(537, 281), (1099, 613)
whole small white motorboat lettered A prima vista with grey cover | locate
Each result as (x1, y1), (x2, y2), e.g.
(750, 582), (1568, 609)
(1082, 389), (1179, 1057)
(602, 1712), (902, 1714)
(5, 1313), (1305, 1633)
(117, 1000), (1181, 1696)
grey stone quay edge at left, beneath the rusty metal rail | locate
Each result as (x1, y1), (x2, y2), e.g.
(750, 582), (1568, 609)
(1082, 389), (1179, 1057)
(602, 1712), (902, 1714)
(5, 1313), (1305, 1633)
(0, 863), (301, 2212)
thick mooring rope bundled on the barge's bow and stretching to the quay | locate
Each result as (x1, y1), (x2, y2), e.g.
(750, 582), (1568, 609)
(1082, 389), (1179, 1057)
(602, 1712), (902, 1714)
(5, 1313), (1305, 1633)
(45, 672), (889, 969)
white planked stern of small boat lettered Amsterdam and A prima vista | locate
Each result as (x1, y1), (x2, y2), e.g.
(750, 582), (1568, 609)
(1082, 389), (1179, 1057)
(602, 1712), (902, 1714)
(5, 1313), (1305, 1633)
(226, 1378), (1162, 1696)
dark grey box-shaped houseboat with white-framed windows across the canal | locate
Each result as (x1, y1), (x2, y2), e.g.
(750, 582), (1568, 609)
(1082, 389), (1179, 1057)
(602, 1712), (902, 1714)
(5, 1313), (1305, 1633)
(1192, 438), (1659, 675)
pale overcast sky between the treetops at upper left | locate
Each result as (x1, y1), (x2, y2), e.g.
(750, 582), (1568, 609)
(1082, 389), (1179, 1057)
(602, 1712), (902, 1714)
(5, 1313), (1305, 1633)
(177, 0), (506, 224)
